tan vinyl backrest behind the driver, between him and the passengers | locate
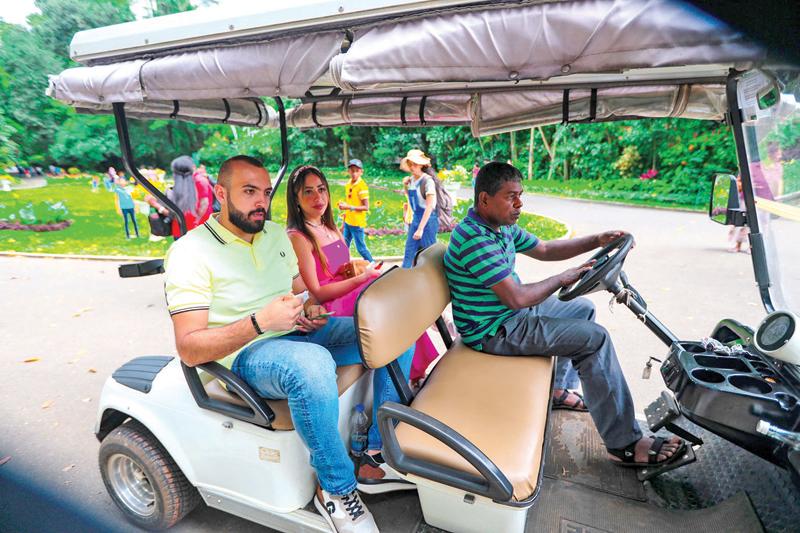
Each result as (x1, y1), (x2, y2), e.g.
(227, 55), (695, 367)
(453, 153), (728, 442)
(355, 243), (450, 368)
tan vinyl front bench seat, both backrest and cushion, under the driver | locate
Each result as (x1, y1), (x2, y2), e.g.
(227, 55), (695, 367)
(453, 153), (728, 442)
(356, 244), (553, 502)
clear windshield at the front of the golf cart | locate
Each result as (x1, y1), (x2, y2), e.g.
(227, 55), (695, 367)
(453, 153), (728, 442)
(740, 72), (800, 312)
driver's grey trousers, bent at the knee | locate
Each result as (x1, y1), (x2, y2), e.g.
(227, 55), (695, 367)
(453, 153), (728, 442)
(482, 296), (642, 449)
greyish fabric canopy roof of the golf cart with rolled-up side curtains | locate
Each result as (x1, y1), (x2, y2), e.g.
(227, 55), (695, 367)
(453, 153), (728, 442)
(48, 0), (767, 135)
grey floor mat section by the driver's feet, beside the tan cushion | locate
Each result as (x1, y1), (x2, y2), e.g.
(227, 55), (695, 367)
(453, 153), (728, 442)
(544, 410), (647, 502)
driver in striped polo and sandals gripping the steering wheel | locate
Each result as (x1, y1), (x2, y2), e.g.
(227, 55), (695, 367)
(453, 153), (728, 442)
(444, 162), (684, 466)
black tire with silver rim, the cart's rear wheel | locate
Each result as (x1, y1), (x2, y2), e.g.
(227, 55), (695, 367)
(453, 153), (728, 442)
(99, 421), (201, 530)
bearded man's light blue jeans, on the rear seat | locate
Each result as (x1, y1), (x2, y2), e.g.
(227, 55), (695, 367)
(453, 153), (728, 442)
(231, 317), (414, 495)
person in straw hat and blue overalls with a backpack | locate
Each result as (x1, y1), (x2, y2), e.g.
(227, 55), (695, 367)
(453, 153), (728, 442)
(400, 150), (439, 268)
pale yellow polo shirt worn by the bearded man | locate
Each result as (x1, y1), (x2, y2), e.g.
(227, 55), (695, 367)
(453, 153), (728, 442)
(164, 216), (300, 368)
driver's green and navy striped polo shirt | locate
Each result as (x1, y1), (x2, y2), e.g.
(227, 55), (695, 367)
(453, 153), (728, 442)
(444, 209), (539, 350)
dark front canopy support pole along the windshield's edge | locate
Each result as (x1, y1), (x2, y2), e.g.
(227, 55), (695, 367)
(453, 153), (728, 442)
(725, 70), (775, 313)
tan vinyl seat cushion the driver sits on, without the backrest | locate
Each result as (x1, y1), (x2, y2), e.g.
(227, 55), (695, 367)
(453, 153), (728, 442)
(397, 343), (553, 501)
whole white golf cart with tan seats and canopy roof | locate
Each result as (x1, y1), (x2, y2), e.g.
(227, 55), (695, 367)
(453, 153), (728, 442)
(49, 0), (800, 532)
